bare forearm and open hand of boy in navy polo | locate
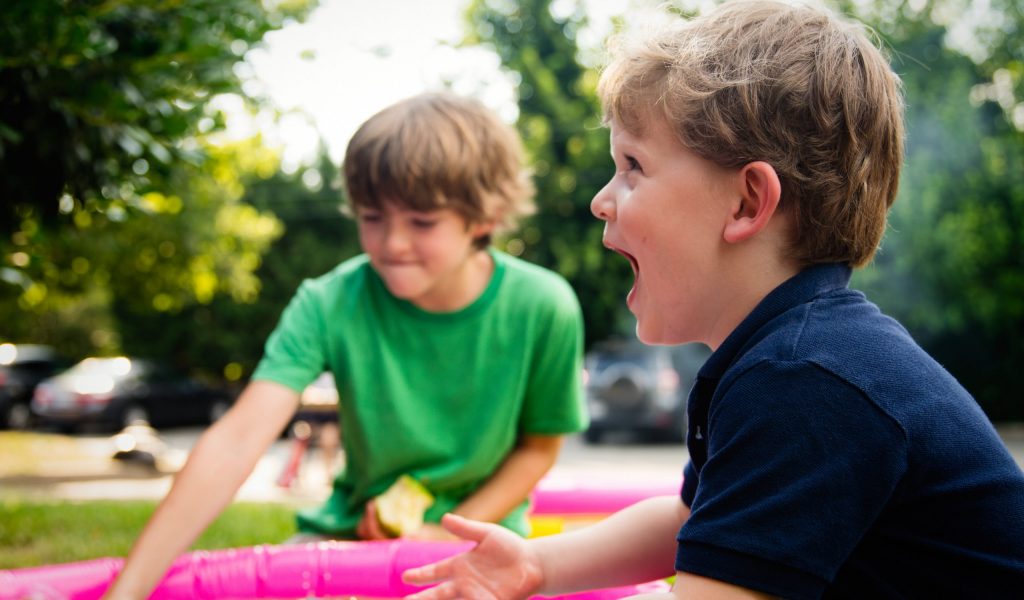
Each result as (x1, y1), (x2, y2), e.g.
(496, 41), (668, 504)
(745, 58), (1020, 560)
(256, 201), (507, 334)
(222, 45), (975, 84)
(404, 497), (689, 600)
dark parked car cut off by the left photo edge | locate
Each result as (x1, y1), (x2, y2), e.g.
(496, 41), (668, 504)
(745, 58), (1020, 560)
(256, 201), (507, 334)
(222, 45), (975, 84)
(0, 344), (71, 429)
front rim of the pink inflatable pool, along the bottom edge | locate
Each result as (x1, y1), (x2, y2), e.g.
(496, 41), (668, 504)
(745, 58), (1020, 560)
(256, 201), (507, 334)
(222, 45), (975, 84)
(0, 540), (669, 600)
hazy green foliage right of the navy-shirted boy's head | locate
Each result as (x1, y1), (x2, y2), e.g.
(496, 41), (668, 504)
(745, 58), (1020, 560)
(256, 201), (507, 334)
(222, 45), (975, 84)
(839, 1), (1024, 421)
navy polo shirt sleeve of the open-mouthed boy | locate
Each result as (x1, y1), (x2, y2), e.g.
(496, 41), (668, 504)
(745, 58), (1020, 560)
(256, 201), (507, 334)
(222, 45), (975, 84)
(676, 360), (907, 598)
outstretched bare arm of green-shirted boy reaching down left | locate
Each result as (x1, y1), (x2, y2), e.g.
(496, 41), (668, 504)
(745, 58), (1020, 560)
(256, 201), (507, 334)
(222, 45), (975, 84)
(104, 382), (299, 600)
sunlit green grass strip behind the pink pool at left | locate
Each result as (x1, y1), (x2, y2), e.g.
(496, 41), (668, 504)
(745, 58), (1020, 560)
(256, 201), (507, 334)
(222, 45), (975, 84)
(0, 498), (295, 569)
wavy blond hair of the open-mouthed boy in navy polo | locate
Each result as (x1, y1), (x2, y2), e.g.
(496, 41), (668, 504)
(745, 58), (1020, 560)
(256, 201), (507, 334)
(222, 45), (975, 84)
(598, 0), (903, 267)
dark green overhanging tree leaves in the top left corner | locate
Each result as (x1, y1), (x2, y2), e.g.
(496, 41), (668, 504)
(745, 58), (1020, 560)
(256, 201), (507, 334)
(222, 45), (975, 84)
(0, 0), (311, 233)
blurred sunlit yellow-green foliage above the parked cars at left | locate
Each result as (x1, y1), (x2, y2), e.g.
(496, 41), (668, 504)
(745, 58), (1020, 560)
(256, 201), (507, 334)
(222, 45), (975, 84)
(0, 139), (282, 367)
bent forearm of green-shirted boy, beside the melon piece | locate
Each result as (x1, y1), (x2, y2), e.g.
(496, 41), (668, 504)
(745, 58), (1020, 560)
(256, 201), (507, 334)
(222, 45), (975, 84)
(452, 435), (562, 523)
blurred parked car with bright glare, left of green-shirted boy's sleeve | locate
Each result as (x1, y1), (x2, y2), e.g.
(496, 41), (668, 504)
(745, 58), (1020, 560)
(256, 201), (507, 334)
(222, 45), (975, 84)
(32, 356), (232, 429)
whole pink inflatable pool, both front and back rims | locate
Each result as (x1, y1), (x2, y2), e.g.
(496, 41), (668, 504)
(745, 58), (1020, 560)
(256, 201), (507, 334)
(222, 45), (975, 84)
(6, 475), (682, 600)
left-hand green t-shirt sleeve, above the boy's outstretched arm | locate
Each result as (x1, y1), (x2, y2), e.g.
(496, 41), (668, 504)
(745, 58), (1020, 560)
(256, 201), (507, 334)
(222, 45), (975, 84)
(252, 281), (327, 393)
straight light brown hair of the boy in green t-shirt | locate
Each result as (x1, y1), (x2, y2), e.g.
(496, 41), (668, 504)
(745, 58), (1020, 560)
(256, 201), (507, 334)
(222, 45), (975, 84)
(343, 92), (535, 245)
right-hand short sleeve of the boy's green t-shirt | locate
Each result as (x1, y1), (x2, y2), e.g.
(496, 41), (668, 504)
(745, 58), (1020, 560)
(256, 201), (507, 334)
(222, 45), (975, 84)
(520, 280), (589, 435)
